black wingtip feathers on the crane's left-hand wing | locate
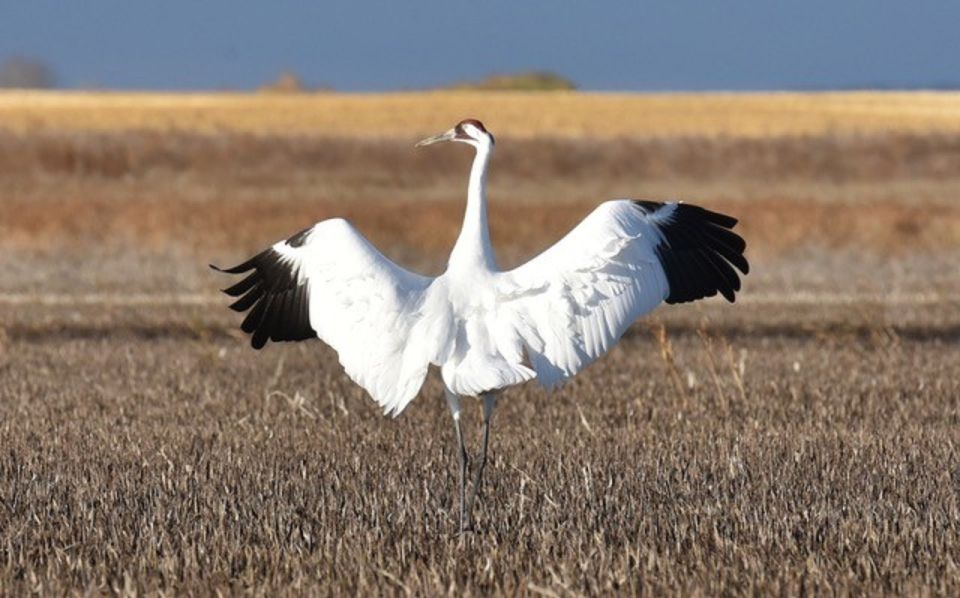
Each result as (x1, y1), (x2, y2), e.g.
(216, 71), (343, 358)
(210, 245), (316, 349)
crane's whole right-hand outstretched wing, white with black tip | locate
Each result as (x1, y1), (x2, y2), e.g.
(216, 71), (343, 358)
(499, 200), (749, 387)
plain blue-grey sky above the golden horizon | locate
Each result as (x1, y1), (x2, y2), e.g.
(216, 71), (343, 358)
(0, 0), (960, 91)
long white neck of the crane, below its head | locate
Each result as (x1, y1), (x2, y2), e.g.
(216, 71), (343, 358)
(448, 143), (497, 270)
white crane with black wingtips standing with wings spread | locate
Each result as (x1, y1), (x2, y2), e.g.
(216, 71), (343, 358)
(213, 119), (749, 532)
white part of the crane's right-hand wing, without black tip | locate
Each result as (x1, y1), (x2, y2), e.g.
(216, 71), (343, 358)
(500, 200), (669, 388)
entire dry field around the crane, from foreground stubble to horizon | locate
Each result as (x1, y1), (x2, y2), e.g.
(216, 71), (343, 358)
(0, 93), (960, 595)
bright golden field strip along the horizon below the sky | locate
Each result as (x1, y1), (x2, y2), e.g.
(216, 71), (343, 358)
(0, 91), (960, 139)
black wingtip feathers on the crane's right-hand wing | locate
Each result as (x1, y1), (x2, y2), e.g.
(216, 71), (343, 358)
(634, 201), (750, 303)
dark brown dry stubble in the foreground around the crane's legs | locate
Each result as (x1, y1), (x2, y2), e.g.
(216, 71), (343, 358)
(0, 310), (960, 595)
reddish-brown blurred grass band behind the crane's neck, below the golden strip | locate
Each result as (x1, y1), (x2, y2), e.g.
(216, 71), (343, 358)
(0, 132), (960, 268)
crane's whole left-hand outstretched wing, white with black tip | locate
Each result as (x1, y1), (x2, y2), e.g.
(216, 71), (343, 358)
(214, 219), (433, 413)
